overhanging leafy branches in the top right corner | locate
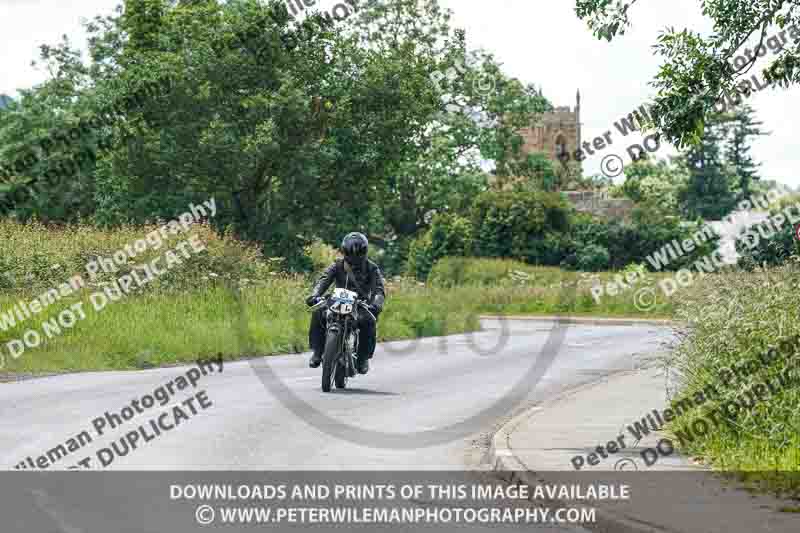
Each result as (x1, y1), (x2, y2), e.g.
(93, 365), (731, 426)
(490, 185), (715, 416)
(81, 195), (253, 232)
(575, 0), (800, 148)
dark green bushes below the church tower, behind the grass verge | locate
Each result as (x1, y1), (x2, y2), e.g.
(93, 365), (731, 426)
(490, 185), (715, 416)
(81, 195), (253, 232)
(407, 190), (716, 274)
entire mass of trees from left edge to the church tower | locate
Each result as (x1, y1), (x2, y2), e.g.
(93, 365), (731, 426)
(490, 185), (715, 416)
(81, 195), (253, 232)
(0, 0), (548, 269)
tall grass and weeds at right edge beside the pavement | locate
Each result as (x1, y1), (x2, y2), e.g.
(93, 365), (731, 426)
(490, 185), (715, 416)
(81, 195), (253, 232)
(670, 264), (800, 474)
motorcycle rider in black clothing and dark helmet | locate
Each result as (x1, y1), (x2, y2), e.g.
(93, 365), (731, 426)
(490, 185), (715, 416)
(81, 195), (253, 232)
(306, 232), (386, 374)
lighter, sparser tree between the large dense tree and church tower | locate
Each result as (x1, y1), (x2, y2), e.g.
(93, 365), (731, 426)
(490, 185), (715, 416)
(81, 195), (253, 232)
(355, 0), (546, 242)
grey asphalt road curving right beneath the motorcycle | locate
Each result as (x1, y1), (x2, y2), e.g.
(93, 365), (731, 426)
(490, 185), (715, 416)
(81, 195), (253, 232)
(0, 320), (672, 470)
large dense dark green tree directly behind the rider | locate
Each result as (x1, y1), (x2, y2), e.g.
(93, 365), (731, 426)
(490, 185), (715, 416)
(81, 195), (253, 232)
(101, 0), (430, 268)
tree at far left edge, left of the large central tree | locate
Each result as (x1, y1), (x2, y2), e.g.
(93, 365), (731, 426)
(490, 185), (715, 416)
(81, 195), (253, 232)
(0, 32), (104, 222)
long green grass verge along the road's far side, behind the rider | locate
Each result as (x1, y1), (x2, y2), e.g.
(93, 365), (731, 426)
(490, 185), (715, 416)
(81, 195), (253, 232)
(0, 260), (680, 373)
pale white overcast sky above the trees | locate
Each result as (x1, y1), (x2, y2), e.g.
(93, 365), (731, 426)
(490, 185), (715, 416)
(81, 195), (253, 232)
(0, 0), (800, 187)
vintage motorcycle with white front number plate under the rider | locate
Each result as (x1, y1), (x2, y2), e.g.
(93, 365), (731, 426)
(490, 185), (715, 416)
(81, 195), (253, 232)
(309, 289), (375, 392)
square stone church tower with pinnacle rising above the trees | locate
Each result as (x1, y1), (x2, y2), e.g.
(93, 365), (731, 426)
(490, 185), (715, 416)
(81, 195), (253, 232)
(519, 90), (581, 163)
